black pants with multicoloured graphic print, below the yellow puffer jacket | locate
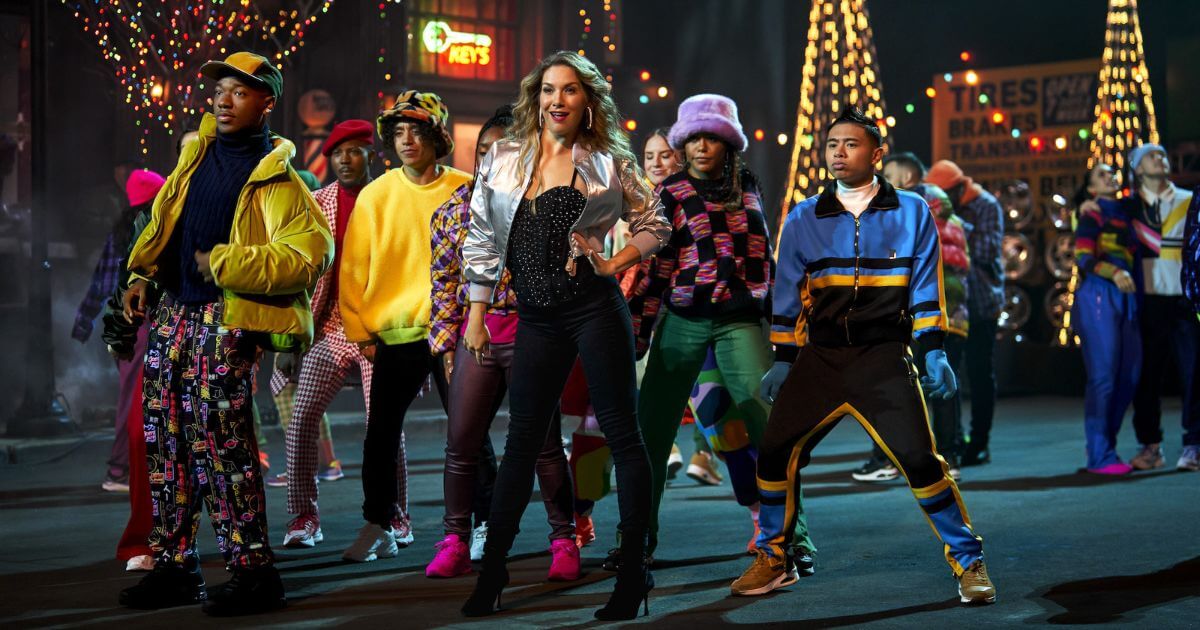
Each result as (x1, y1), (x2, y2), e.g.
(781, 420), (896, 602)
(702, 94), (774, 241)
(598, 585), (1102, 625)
(143, 298), (274, 568)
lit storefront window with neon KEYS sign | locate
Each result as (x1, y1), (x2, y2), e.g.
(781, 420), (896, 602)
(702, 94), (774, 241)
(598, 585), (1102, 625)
(408, 0), (517, 82)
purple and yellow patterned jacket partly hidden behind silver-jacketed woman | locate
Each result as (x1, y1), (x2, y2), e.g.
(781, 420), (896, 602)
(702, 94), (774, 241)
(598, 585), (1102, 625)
(430, 182), (517, 354)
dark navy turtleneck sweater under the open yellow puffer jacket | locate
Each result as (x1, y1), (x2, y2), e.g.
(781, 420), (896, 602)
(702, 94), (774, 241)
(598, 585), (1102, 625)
(174, 126), (271, 305)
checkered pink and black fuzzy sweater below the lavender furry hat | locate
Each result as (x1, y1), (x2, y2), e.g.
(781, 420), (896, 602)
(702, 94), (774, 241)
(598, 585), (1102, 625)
(629, 170), (774, 344)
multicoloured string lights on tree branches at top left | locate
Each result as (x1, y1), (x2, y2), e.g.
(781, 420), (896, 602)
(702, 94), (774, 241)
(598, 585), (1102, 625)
(61, 0), (334, 154)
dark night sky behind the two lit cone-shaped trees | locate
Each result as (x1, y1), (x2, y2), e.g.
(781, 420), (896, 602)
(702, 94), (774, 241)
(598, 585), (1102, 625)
(617, 0), (1200, 217)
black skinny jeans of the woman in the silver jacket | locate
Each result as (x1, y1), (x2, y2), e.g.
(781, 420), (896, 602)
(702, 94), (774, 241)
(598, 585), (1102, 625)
(484, 277), (650, 566)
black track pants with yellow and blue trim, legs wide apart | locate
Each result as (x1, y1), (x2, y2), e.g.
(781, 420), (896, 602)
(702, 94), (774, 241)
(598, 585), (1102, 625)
(757, 342), (983, 575)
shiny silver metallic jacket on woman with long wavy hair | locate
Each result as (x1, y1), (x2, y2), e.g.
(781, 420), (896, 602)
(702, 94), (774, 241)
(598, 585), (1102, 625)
(462, 139), (671, 304)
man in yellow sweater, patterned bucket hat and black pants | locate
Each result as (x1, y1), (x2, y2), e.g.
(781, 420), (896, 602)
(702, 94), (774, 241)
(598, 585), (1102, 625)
(338, 90), (470, 562)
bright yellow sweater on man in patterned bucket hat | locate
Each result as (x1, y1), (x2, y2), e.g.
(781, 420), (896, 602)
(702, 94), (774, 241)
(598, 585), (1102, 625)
(337, 167), (470, 346)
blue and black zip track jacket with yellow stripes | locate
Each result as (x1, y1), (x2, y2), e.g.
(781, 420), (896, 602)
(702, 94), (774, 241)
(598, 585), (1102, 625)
(770, 178), (947, 362)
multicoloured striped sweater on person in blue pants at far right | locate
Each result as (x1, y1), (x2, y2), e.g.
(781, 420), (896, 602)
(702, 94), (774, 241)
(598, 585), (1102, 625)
(1075, 199), (1138, 280)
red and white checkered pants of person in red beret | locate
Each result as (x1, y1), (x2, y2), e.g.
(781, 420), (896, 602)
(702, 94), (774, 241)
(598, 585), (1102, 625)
(278, 311), (408, 521)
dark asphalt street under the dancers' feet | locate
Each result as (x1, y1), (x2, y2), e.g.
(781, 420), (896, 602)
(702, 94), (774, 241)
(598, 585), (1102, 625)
(0, 398), (1200, 628)
